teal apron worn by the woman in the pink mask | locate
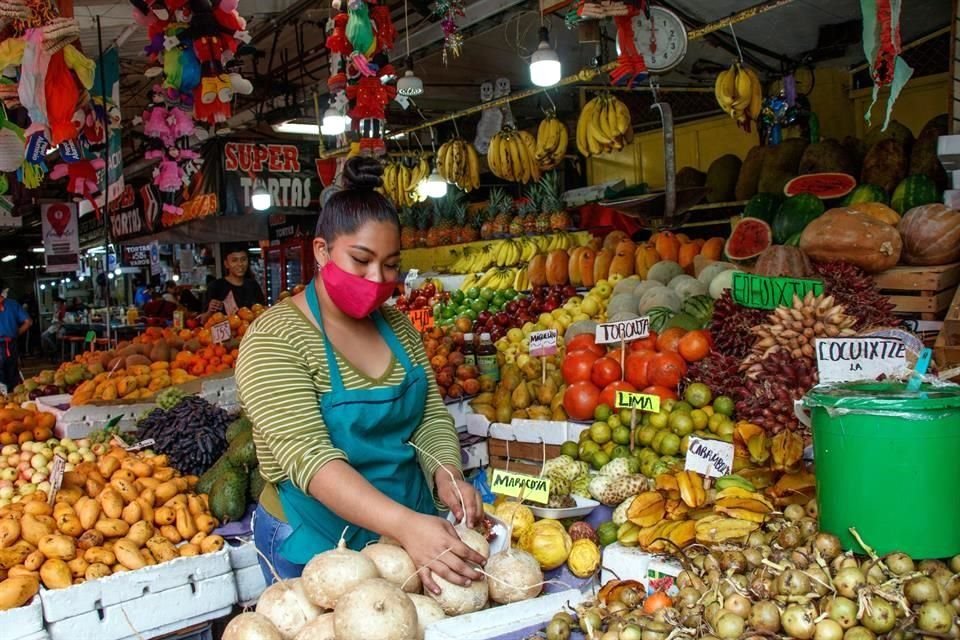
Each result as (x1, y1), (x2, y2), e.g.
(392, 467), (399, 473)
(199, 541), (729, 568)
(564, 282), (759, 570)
(278, 282), (436, 564)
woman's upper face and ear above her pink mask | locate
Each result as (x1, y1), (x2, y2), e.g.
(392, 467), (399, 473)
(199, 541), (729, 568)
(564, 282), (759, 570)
(313, 221), (400, 282)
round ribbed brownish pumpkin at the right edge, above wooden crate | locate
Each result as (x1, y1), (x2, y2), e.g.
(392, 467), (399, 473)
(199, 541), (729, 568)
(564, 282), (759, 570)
(899, 203), (960, 265)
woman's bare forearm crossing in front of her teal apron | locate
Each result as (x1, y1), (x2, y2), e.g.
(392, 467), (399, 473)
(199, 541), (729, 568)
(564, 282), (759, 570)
(309, 460), (415, 537)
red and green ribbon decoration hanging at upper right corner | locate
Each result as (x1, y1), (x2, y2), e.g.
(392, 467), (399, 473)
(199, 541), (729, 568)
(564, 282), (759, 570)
(860, 0), (913, 131)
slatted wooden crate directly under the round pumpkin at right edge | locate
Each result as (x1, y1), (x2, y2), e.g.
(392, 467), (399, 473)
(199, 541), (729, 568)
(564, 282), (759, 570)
(873, 262), (960, 320)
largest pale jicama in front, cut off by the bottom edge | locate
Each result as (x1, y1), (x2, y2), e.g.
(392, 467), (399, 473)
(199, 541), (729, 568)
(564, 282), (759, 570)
(333, 578), (418, 640)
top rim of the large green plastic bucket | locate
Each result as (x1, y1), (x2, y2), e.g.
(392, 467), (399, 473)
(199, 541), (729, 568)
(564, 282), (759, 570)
(803, 381), (960, 412)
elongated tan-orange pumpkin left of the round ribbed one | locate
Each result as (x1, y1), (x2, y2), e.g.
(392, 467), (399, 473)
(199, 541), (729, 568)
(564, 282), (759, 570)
(800, 207), (903, 273)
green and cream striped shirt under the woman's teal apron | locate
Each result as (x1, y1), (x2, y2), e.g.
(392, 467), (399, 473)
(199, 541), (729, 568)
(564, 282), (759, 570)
(236, 300), (460, 515)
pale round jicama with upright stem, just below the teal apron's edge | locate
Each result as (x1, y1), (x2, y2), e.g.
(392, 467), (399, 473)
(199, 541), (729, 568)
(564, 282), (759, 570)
(303, 538), (380, 609)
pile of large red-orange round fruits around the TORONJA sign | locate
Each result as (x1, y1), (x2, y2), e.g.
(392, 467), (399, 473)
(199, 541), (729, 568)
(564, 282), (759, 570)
(562, 328), (711, 420)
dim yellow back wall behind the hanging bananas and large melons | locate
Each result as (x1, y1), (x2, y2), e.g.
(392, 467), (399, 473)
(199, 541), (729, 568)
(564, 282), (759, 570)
(587, 69), (950, 188)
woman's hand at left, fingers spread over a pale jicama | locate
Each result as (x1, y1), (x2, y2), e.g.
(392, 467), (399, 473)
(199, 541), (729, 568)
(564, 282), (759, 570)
(395, 514), (487, 594)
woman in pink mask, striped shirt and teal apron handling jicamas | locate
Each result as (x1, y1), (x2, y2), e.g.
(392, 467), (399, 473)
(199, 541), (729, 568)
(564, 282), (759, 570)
(236, 158), (483, 592)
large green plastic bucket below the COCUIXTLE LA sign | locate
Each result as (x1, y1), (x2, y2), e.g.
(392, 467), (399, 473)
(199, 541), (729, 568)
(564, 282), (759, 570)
(803, 382), (960, 559)
